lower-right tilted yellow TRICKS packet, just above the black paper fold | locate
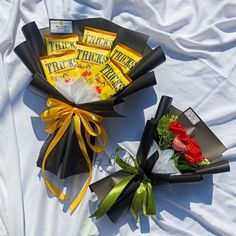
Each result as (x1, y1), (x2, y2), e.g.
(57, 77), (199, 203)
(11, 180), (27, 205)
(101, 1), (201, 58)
(95, 60), (132, 100)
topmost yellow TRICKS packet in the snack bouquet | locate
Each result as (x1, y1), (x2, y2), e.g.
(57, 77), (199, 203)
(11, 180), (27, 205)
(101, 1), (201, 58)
(82, 26), (117, 49)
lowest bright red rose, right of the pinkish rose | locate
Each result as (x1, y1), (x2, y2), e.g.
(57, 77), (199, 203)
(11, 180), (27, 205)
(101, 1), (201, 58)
(183, 139), (205, 164)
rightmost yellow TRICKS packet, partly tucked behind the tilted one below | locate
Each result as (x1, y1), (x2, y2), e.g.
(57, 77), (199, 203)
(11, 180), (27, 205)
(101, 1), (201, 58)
(110, 44), (143, 74)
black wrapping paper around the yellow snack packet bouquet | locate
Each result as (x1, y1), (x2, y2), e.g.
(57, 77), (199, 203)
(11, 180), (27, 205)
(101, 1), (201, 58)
(14, 18), (165, 178)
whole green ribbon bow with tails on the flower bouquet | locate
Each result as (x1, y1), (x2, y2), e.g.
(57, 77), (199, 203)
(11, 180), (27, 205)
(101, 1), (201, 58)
(91, 147), (156, 221)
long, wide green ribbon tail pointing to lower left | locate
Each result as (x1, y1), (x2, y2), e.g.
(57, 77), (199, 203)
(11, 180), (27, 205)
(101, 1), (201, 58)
(90, 174), (136, 219)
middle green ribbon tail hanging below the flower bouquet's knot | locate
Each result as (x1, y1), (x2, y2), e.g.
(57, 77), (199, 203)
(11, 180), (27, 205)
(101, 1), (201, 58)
(130, 183), (146, 221)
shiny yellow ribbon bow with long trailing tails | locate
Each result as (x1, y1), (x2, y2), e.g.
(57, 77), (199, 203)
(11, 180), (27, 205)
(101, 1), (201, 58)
(41, 98), (107, 213)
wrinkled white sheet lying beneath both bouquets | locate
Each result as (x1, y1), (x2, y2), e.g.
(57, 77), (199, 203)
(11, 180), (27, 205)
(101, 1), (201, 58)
(0, 0), (236, 236)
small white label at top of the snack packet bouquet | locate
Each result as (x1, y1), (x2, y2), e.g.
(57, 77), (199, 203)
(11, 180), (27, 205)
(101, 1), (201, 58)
(50, 20), (73, 34)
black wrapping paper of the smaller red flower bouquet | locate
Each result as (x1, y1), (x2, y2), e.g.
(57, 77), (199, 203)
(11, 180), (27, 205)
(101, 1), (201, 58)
(90, 96), (229, 222)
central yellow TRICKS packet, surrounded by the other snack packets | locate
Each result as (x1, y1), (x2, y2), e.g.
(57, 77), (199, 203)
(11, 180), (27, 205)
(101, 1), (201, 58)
(77, 43), (110, 84)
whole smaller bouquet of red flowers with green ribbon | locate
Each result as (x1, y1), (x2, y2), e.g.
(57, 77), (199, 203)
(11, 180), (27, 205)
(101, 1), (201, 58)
(90, 96), (229, 222)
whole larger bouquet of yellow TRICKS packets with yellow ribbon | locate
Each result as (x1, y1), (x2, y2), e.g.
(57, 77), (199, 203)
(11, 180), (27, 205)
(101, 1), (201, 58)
(14, 18), (165, 212)
